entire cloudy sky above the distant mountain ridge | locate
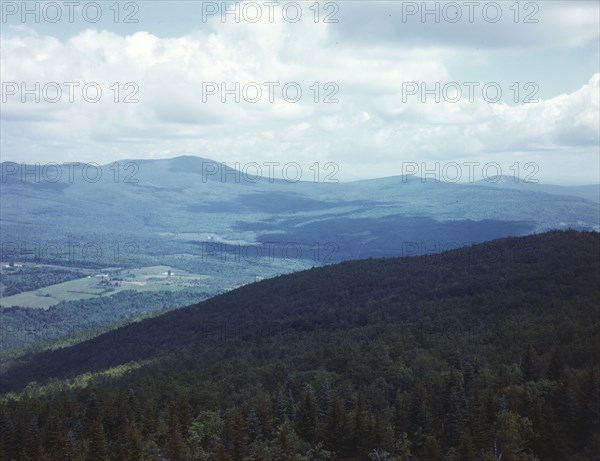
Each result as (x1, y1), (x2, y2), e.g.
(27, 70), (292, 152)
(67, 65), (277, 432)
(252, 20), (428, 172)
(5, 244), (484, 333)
(0, 1), (600, 184)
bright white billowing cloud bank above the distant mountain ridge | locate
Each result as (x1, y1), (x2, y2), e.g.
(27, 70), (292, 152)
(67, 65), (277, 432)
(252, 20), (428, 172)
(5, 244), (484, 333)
(0, 2), (600, 182)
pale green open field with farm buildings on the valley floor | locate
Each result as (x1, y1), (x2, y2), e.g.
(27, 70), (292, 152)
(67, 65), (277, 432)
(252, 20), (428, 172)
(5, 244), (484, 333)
(0, 266), (211, 309)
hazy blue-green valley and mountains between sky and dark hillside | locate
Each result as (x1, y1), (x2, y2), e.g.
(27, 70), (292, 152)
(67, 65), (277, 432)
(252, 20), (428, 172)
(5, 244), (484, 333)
(0, 156), (600, 354)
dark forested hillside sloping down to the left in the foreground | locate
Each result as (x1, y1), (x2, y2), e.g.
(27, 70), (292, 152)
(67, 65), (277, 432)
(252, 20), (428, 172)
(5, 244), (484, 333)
(0, 231), (600, 461)
